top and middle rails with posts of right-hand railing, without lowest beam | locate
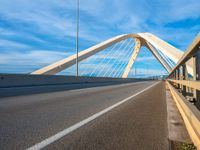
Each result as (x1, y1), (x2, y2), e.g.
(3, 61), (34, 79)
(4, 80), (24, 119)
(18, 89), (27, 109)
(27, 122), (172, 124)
(167, 33), (200, 110)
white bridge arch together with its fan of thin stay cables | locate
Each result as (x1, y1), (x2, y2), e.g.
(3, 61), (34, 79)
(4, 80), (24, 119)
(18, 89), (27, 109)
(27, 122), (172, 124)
(32, 33), (192, 78)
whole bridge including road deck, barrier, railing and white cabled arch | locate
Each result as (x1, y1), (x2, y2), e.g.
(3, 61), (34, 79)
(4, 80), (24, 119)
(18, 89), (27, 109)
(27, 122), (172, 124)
(0, 33), (200, 150)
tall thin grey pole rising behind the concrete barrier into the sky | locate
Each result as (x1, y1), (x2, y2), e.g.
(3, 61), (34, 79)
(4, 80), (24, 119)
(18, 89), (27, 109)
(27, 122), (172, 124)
(76, 0), (79, 77)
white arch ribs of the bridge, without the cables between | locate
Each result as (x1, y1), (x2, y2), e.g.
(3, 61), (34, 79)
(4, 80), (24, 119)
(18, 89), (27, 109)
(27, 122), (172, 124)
(31, 33), (192, 78)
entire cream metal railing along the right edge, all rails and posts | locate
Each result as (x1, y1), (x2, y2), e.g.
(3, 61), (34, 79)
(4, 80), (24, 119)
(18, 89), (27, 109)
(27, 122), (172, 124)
(167, 33), (200, 149)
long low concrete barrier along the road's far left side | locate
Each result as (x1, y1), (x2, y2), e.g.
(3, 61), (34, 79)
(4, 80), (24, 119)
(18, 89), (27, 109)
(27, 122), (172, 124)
(0, 74), (146, 88)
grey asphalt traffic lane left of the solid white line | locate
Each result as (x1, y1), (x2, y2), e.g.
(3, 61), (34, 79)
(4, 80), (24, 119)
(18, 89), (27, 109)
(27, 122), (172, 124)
(0, 81), (166, 149)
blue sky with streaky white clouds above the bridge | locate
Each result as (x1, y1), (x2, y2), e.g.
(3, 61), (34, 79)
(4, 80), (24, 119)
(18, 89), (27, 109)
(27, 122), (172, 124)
(0, 0), (200, 75)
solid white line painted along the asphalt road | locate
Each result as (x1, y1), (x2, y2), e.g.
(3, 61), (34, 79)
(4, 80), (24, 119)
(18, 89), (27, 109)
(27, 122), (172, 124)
(27, 82), (159, 150)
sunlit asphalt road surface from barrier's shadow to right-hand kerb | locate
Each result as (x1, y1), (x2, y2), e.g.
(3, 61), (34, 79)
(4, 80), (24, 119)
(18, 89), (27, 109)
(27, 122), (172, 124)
(0, 81), (168, 150)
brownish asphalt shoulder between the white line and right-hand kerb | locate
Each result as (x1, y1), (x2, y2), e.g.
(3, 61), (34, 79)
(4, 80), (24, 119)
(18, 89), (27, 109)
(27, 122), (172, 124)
(48, 83), (168, 150)
